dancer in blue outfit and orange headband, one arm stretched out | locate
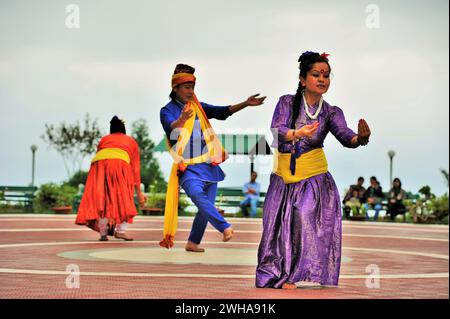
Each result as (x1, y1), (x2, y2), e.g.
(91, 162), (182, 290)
(160, 64), (265, 252)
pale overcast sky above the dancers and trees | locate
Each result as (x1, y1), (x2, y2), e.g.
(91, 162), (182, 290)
(0, 0), (449, 194)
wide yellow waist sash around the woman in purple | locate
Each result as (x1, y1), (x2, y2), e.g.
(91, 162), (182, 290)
(273, 148), (328, 184)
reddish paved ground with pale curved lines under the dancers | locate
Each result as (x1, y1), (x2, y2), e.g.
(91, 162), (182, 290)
(0, 215), (449, 299)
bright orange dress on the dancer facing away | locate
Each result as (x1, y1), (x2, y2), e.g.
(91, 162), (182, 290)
(75, 133), (141, 233)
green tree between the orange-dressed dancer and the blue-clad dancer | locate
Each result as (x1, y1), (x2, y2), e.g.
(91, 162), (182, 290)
(131, 119), (167, 192)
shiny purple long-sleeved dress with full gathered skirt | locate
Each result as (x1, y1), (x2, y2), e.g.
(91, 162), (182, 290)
(256, 95), (357, 288)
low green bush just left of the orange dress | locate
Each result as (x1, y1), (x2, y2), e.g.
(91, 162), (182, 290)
(34, 183), (77, 212)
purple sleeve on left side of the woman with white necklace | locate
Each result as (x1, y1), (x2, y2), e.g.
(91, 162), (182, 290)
(270, 95), (291, 147)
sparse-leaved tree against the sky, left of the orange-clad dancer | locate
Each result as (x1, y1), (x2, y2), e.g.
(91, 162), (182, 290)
(41, 113), (103, 179)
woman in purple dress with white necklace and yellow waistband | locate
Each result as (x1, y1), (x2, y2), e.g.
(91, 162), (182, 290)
(256, 51), (370, 289)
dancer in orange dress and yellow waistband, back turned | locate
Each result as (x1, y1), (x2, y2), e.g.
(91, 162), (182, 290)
(75, 116), (146, 241)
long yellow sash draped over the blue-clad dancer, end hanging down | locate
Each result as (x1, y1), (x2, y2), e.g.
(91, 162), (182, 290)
(159, 95), (228, 248)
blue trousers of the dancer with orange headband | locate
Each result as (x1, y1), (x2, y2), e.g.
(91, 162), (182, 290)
(182, 179), (231, 245)
